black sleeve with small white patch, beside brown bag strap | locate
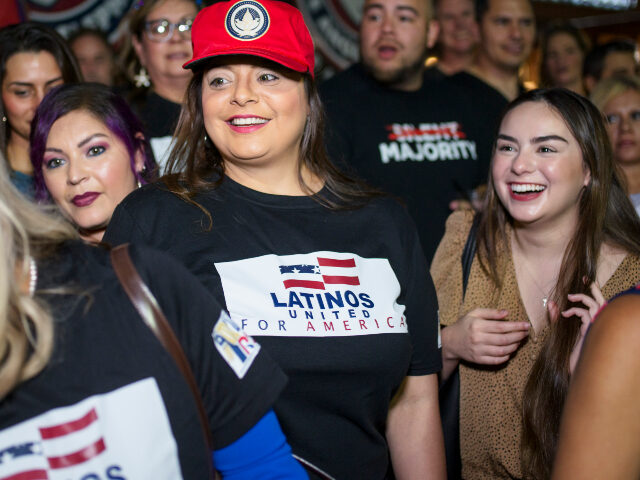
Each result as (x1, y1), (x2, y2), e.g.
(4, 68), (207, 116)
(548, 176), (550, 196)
(130, 247), (286, 449)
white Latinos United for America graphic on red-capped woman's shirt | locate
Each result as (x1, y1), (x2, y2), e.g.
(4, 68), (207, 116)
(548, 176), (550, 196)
(215, 251), (408, 337)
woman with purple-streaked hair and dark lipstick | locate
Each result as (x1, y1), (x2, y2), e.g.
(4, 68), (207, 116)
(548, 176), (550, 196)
(30, 83), (155, 242)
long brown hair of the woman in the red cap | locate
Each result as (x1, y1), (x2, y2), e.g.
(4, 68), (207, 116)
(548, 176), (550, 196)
(164, 64), (379, 225)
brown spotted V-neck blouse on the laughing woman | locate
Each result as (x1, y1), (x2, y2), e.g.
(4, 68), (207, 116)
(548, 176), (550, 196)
(431, 211), (640, 480)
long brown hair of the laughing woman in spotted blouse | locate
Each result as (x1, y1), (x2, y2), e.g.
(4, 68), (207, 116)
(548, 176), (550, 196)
(478, 88), (640, 479)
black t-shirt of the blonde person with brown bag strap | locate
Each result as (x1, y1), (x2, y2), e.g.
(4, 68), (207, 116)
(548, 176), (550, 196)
(0, 242), (286, 480)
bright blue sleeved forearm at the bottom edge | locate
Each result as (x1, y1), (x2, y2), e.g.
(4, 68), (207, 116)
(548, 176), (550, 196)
(213, 410), (309, 480)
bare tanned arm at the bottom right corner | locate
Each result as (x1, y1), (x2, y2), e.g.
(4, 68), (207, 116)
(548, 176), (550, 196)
(552, 295), (640, 480)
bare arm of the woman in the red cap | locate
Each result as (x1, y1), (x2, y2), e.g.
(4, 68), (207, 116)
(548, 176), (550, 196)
(386, 373), (446, 480)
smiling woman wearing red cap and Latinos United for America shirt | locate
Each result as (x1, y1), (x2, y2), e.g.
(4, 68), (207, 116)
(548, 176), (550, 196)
(104, 0), (444, 479)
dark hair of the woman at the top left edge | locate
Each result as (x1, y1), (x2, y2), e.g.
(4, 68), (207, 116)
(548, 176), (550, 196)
(0, 22), (82, 153)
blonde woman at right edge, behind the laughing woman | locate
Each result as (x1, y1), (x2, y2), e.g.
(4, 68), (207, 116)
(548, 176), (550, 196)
(591, 77), (640, 214)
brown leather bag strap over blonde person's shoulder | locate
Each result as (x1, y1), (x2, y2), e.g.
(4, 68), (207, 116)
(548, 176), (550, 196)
(111, 244), (213, 466)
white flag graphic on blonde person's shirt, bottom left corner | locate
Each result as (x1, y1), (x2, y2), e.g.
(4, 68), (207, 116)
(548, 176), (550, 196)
(0, 378), (182, 480)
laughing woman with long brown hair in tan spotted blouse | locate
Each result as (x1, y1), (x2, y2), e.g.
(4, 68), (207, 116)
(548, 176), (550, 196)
(431, 89), (640, 479)
